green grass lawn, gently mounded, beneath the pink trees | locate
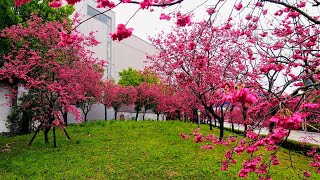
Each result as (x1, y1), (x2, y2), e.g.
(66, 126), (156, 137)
(0, 121), (320, 180)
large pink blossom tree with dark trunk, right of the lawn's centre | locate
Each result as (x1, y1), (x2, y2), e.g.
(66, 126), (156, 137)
(149, 21), (256, 138)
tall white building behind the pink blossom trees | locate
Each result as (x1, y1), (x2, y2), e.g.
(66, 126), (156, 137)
(69, 0), (156, 121)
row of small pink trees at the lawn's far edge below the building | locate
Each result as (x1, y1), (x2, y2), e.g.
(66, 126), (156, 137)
(101, 71), (192, 120)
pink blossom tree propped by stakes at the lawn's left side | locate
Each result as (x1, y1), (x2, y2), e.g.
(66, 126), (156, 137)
(0, 15), (104, 146)
